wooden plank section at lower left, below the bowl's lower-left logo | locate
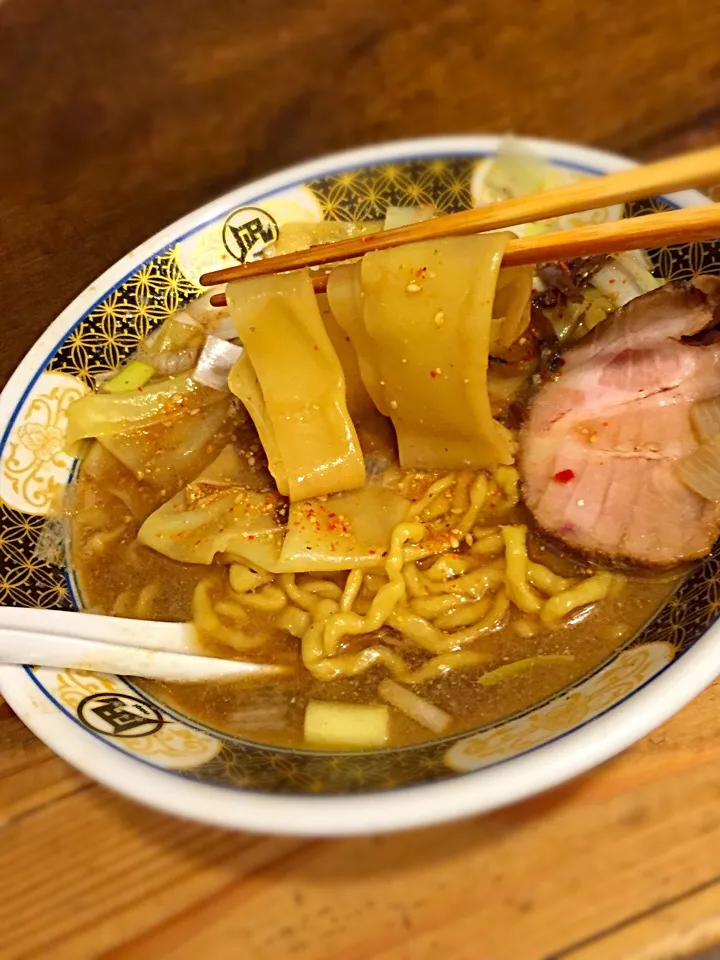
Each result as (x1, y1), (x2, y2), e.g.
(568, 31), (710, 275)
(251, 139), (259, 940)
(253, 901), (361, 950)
(0, 787), (301, 960)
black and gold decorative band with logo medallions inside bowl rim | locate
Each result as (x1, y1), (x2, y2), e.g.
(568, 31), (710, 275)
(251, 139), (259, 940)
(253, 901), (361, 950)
(0, 141), (720, 819)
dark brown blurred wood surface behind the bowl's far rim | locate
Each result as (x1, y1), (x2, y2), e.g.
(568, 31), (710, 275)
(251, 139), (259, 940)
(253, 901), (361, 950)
(0, 0), (720, 380)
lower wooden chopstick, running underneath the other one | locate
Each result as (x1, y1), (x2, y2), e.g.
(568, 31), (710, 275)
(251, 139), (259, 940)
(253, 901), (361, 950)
(210, 203), (720, 307)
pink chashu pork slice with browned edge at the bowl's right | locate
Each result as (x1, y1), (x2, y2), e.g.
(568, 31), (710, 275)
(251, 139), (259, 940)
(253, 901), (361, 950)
(520, 278), (720, 566)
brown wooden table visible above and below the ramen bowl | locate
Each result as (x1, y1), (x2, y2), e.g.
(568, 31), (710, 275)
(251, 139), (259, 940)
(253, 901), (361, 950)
(0, 0), (720, 960)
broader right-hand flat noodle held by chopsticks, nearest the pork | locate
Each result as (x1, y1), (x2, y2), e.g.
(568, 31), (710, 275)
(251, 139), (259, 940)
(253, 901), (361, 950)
(358, 233), (513, 470)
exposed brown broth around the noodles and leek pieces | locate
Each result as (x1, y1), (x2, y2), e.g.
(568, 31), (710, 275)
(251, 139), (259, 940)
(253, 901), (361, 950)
(70, 447), (682, 746)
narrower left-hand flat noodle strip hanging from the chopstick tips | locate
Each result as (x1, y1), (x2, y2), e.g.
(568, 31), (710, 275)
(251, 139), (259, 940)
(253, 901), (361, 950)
(227, 270), (365, 500)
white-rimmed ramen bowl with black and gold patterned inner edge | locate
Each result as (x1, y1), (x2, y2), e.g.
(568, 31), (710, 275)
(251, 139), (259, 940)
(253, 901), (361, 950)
(0, 136), (720, 835)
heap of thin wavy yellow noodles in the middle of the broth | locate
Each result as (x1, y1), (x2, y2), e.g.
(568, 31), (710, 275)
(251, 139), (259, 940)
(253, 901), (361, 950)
(186, 480), (613, 683)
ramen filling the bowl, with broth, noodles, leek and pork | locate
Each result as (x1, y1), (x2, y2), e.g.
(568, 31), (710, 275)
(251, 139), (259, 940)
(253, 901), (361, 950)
(68, 206), (720, 750)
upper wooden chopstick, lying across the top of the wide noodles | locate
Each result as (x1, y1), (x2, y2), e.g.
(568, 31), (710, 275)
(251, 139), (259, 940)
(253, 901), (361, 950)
(200, 141), (720, 286)
